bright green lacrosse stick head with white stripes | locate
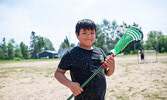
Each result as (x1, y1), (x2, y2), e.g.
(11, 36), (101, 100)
(109, 27), (143, 55)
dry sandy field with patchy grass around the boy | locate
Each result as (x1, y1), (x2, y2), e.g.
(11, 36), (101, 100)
(0, 55), (167, 100)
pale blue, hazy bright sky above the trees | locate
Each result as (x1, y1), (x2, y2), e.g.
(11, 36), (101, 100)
(0, 0), (167, 50)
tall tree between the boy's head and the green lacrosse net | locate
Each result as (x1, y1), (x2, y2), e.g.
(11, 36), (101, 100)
(94, 19), (122, 53)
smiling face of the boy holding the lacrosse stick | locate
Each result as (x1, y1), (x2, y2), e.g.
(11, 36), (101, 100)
(76, 28), (96, 47)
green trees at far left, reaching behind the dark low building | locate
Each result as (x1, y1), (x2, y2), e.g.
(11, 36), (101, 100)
(0, 31), (55, 59)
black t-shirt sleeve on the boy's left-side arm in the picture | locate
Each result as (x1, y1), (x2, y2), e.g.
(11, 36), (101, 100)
(58, 51), (72, 70)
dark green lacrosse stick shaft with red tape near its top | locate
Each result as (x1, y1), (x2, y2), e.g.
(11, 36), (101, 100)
(67, 55), (115, 100)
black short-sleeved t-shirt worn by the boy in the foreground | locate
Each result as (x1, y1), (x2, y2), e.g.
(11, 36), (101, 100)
(58, 47), (106, 100)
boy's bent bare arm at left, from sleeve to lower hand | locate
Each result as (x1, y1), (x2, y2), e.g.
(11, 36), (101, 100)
(54, 68), (83, 96)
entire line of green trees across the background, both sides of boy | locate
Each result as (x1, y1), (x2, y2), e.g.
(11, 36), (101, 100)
(0, 19), (167, 59)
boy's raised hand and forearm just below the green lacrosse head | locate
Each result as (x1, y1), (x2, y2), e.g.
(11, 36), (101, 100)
(104, 56), (115, 76)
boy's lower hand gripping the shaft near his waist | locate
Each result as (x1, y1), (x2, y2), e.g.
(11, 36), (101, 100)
(70, 82), (83, 96)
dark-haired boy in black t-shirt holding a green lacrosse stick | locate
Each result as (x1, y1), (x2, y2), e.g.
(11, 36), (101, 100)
(55, 19), (115, 100)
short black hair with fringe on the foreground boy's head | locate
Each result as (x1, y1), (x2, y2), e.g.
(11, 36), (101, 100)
(75, 19), (96, 35)
